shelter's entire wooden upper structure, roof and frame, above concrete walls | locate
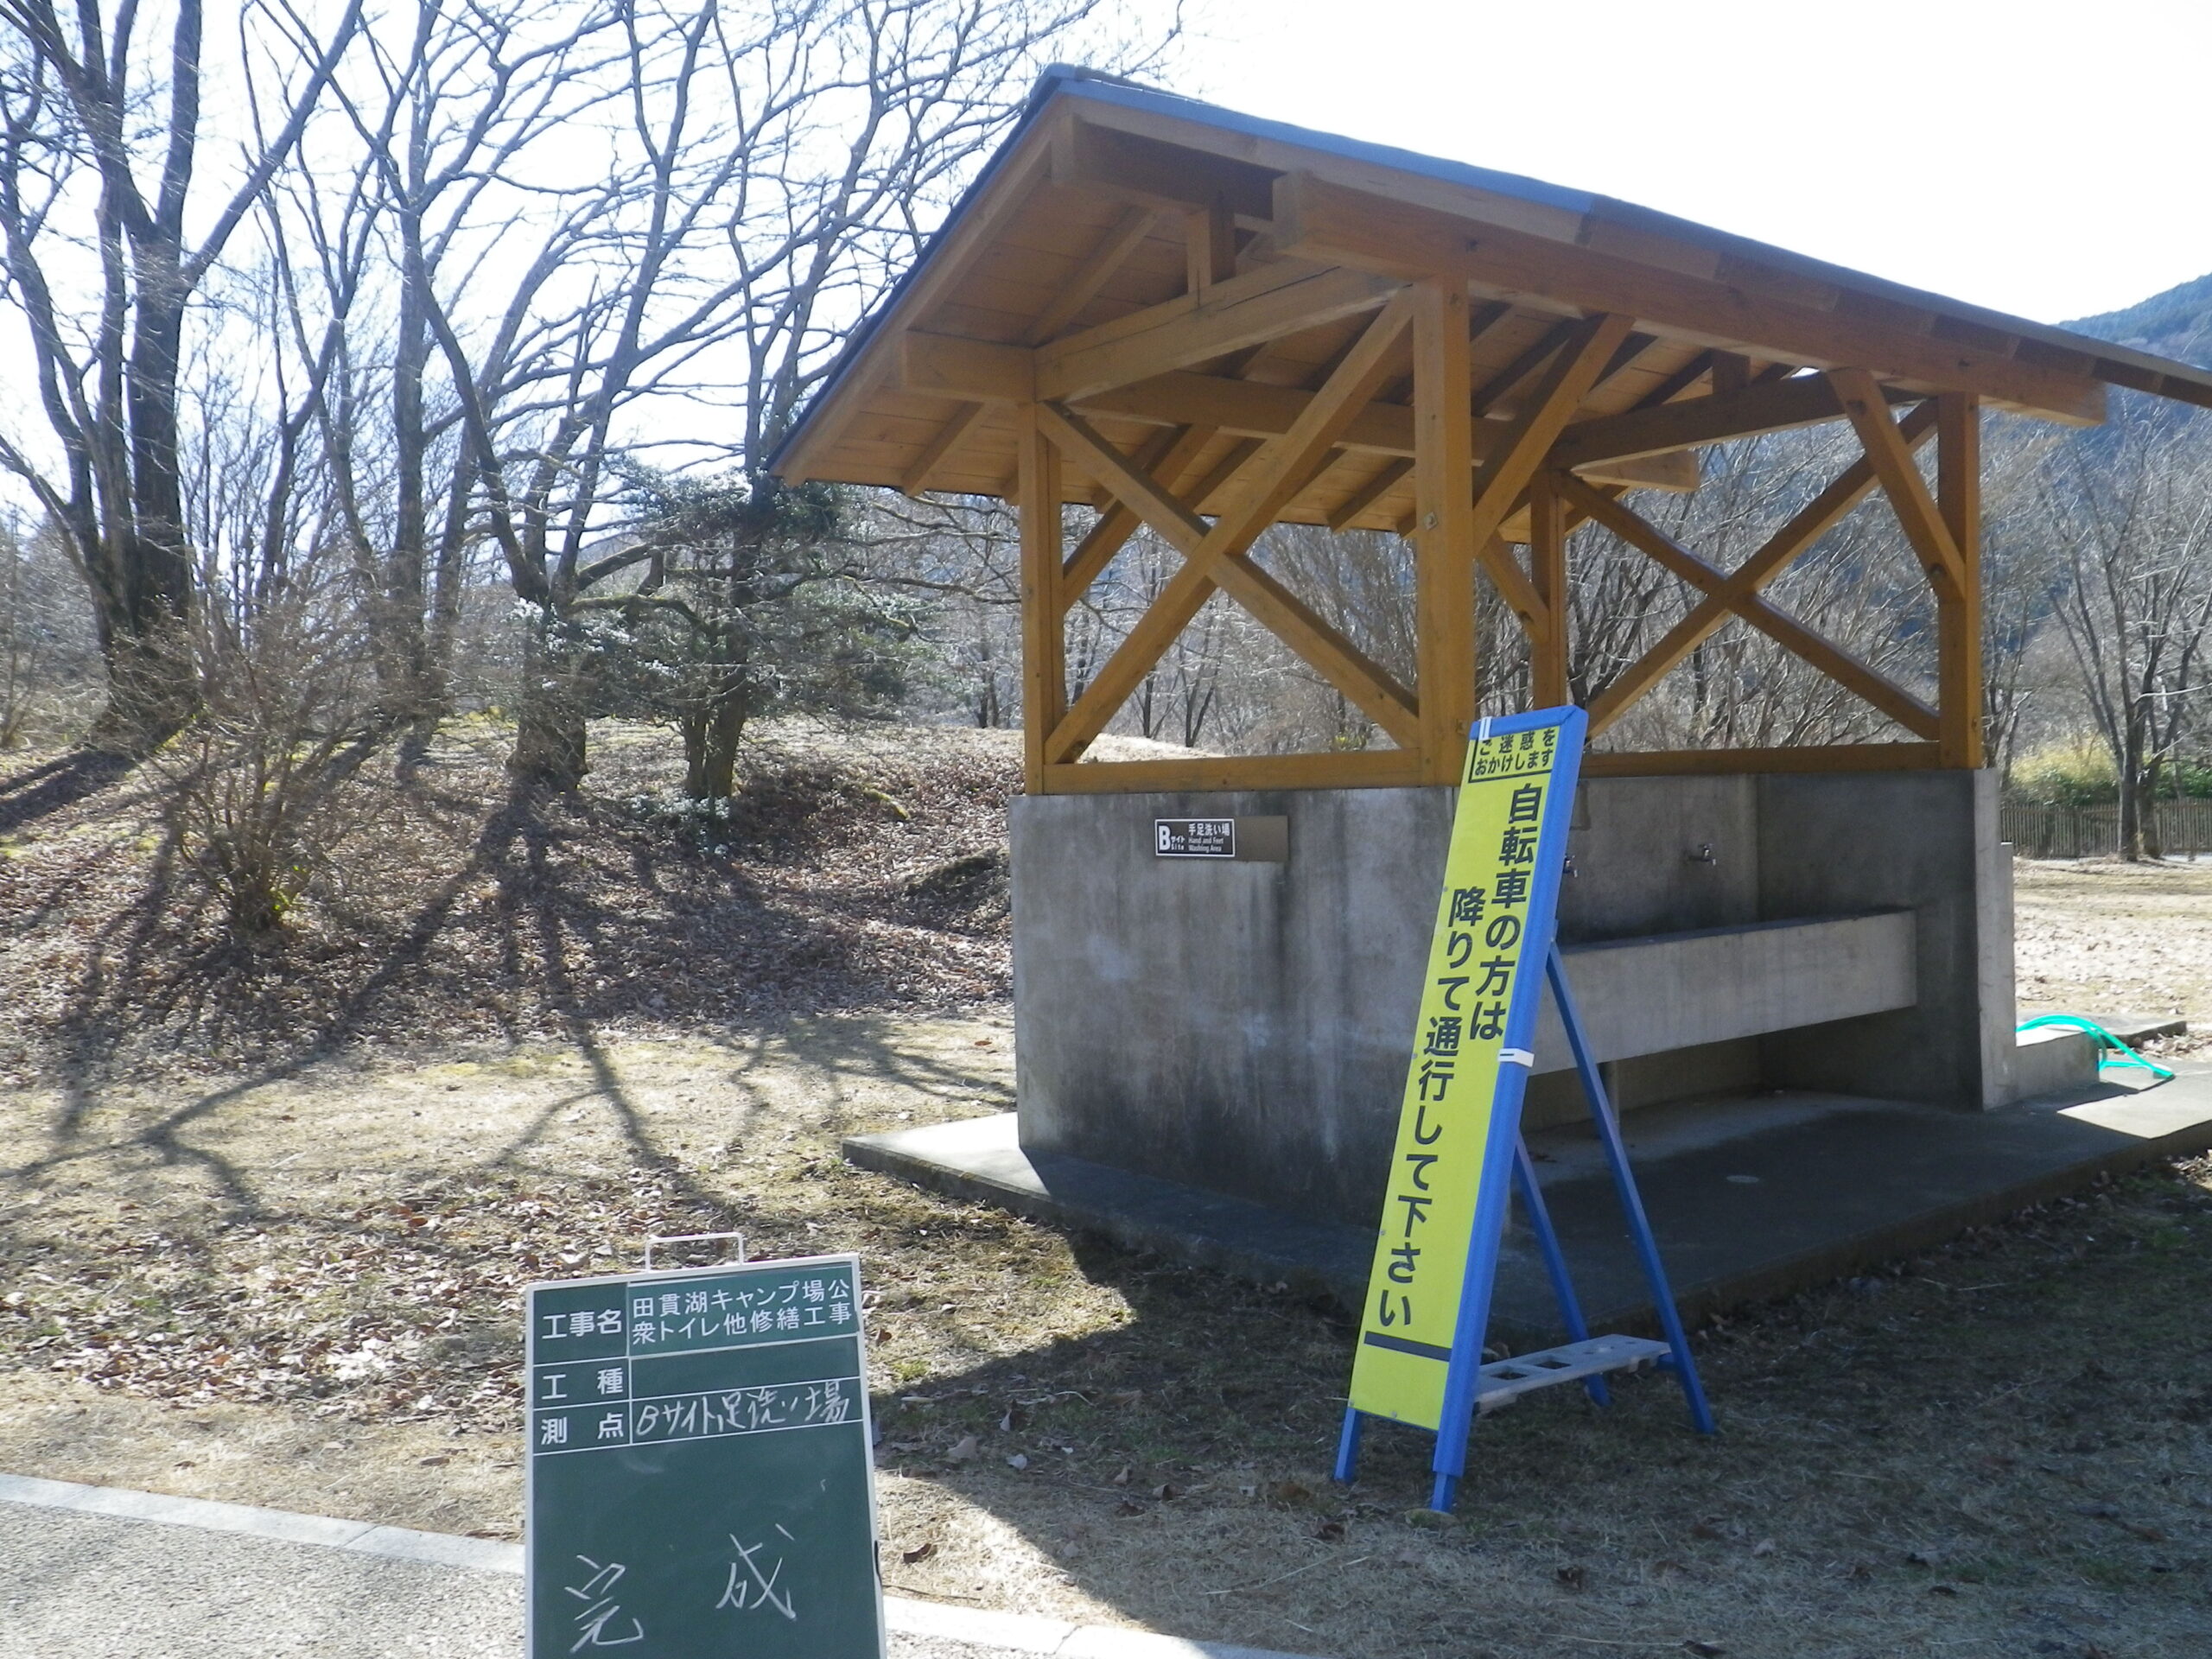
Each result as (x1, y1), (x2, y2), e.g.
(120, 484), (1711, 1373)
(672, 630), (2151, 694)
(772, 68), (2212, 794)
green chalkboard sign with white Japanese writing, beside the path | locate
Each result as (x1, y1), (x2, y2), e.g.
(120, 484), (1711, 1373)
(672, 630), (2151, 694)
(526, 1256), (882, 1659)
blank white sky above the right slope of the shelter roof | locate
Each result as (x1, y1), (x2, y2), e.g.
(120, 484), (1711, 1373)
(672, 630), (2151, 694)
(1174, 0), (2212, 323)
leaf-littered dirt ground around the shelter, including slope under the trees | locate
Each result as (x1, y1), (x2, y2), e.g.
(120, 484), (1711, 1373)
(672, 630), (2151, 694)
(0, 757), (2212, 1659)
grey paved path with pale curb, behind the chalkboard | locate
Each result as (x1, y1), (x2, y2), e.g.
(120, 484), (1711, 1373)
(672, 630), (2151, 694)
(0, 1476), (1296, 1659)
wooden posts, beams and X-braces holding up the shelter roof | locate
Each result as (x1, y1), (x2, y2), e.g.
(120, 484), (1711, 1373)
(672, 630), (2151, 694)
(1004, 285), (1982, 794)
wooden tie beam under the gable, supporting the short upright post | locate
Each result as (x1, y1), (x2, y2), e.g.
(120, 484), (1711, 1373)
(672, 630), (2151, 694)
(1035, 259), (1402, 403)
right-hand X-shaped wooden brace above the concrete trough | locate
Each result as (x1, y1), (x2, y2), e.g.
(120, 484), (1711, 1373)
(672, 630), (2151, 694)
(1560, 394), (1940, 736)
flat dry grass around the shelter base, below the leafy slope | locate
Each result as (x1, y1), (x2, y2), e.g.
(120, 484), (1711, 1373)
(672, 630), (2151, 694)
(0, 1035), (2212, 1659)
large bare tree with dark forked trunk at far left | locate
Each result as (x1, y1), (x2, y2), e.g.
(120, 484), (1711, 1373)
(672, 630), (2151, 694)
(0, 0), (363, 747)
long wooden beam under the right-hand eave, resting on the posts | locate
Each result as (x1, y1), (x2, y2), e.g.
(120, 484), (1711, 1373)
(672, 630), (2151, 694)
(1274, 173), (2104, 425)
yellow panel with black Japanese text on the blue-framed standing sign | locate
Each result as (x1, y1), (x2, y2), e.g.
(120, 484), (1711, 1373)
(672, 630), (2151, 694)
(1351, 710), (1581, 1429)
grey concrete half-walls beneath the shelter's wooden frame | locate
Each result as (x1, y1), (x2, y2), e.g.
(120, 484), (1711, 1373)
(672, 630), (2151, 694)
(1013, 772), (2013, 1224)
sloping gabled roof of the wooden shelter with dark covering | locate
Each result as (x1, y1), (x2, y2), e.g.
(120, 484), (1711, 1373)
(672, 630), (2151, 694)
(770, 67), (2212, 529)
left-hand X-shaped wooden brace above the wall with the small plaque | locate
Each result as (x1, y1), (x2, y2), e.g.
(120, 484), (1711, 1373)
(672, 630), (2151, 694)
(1038, 294), (1421, 763)
